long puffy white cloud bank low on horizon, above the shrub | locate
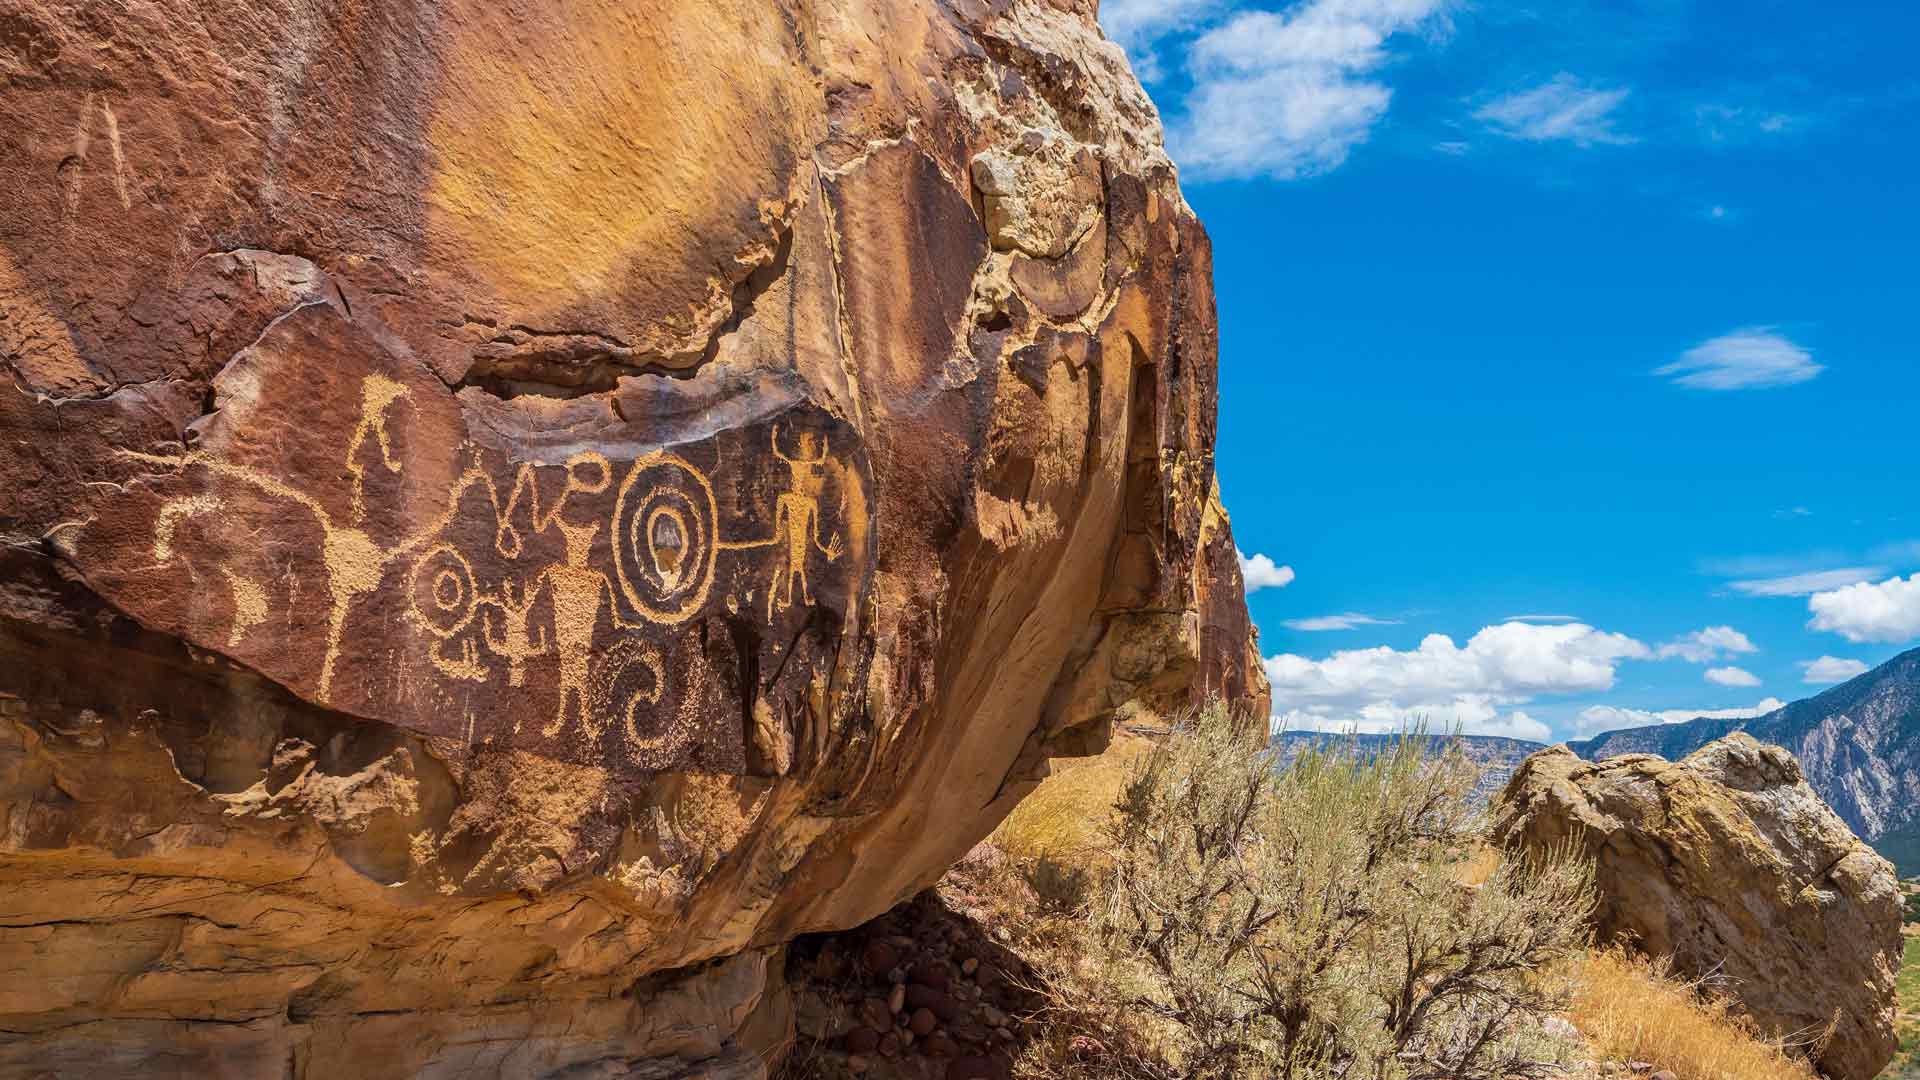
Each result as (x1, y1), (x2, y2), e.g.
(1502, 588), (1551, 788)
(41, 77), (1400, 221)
(1265, 623), (1653, 738)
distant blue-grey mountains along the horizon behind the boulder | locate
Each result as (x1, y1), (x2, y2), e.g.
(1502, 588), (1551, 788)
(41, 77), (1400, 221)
(1275, 650), (1920, 876)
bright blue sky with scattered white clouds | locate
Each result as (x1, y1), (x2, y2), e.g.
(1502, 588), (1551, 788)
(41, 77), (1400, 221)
(1102, 0), (1920, 738)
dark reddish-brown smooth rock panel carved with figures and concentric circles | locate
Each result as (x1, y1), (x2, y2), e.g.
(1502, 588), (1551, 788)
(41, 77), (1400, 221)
(75, 309), (872, 773)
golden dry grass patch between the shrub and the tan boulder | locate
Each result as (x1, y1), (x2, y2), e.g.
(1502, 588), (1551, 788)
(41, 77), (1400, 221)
(1567, 949), (1814, 1080)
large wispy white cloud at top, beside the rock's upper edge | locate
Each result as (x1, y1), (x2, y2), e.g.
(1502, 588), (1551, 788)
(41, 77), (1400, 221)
(1169, 0), (1453, 181)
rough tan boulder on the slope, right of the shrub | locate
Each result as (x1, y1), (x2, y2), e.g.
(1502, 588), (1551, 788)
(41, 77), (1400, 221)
(1494, 734), (1901, 1080)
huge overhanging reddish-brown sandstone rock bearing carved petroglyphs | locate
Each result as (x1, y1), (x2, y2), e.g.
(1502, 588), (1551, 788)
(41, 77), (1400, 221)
(0, 0), (1263, 1078)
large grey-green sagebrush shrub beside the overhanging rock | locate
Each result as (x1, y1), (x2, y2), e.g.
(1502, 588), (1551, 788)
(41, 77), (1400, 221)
(1033, 705), (1594, 1080)
